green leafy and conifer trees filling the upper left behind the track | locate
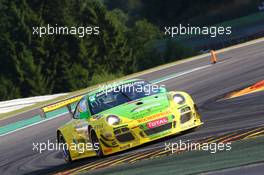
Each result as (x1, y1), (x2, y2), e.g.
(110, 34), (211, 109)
(0, 0), (175, 100)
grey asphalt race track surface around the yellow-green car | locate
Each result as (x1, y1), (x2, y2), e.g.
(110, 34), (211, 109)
(0, 42), (264, 175)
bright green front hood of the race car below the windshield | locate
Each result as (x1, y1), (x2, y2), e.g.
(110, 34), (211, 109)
(101, 93), (169, 119)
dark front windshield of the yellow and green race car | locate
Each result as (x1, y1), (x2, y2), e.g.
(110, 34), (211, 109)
(88, 80), (159, 115)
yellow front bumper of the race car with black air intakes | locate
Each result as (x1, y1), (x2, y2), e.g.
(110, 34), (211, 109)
(99, 105), (203, 155)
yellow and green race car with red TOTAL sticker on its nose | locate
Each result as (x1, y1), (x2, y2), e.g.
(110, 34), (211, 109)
(57, 79), (202, 162)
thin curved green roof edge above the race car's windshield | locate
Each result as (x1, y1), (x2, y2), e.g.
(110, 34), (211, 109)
(86, 79), (144, 96)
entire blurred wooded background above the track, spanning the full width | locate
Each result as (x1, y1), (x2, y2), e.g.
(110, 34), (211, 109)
(0, 0), (264, 101)
